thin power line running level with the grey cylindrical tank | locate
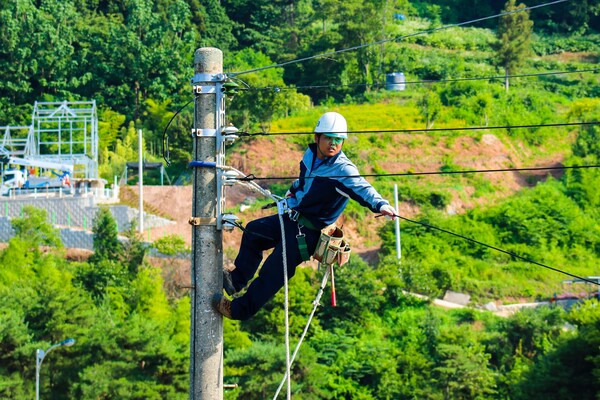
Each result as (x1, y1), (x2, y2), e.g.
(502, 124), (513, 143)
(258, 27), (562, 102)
(246, 68), (600, 92)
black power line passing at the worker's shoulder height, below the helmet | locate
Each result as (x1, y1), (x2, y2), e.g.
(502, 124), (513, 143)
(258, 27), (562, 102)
(234, 165), (600, 182)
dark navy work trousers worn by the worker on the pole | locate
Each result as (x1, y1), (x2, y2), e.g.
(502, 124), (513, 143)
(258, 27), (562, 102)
(231, 215), (321, 320)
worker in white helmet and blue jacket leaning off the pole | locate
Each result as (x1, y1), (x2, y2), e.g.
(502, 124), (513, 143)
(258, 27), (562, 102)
(212, 112), (396, 320)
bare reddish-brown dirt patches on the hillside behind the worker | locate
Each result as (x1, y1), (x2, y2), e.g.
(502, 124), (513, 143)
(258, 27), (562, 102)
(136, 134), (564, 261)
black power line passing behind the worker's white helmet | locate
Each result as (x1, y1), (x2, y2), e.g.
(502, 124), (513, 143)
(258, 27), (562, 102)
(238, 121), (600, 137)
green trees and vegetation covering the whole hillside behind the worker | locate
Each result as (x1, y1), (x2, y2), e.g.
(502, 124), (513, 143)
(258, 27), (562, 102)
(0, 0), (600, 399)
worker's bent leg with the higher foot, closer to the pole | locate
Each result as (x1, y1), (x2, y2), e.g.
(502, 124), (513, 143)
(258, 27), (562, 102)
(230, 215), (287, 292)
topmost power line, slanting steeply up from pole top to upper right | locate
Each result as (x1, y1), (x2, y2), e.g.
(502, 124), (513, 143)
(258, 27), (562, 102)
(228, 0), (569, 76)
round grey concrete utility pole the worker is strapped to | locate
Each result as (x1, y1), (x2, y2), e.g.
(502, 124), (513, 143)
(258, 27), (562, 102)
(190, 47), (224, 400)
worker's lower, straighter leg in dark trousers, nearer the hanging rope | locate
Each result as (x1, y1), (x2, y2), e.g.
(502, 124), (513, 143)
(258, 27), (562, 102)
(231, 216), (321, 320)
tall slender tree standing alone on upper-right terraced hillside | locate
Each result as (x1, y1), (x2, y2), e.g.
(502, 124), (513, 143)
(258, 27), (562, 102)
(495, 0), (533, 92)
